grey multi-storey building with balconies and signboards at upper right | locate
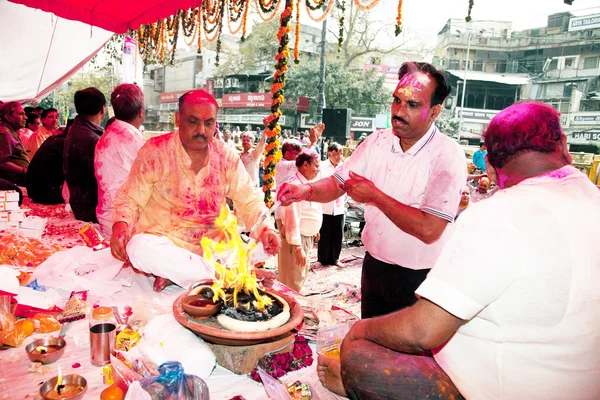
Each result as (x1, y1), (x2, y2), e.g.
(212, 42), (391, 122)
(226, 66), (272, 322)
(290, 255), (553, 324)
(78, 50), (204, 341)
(434, 13), (600, 152)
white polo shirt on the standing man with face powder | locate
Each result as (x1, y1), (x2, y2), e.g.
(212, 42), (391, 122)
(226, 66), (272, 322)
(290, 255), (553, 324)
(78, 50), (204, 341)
(337, 124), (467, 270)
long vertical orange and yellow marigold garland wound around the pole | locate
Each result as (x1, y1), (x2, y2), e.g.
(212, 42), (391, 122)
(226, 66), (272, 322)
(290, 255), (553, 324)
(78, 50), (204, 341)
(258, 0), (294, 206)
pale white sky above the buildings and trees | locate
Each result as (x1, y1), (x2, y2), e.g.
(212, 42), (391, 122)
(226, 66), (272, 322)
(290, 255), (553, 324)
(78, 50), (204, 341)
(284, 0), (600, 46)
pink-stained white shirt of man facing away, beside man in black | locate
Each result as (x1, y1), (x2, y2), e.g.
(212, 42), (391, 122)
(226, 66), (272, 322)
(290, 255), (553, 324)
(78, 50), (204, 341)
(94, 119), (146, 239)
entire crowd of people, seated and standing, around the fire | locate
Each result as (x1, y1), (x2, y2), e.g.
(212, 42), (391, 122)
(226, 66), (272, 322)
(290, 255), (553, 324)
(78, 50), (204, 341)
(0, 62), (600, 399)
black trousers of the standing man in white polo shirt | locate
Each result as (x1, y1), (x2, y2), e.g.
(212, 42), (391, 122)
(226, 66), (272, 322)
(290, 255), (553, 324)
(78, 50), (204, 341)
(360, 252), (429, 318)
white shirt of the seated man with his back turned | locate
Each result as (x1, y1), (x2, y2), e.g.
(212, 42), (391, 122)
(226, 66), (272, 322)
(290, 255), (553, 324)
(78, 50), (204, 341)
(416, 166), (600, 400)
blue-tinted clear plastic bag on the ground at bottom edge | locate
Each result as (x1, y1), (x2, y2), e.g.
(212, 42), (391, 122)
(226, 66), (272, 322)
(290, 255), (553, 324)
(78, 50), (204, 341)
(140, 361), (210, 400)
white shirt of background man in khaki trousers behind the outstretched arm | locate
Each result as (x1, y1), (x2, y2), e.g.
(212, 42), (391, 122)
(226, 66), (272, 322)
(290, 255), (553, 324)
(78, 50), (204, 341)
(281, 171), (323, 246)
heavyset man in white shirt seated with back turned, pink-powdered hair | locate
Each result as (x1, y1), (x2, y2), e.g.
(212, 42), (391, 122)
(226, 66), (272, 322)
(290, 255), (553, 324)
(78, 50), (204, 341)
(320, 102), (600, 400)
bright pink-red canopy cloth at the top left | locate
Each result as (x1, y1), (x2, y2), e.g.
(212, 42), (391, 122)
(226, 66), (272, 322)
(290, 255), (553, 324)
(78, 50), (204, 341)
(9, 0), (202, 33)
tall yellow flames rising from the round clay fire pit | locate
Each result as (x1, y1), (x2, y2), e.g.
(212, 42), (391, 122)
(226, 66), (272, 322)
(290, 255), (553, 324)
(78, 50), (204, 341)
(200, 205), (273, 310)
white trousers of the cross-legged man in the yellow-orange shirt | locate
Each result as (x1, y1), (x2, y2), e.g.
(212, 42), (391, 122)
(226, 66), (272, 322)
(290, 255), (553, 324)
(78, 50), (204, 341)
(127, 233), (215, 289)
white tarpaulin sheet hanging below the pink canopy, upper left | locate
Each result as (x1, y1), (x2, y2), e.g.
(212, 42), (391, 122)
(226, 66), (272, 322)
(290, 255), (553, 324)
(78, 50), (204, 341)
(0, 0), (113, 102)
